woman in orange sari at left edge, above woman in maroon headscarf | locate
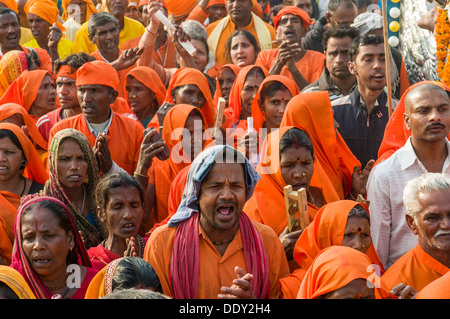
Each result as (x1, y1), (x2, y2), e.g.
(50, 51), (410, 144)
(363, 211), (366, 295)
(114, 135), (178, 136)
(0, 123), (48, 263)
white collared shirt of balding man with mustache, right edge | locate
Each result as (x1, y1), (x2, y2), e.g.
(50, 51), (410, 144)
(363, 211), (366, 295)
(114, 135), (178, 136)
(367, 138), (450, 269)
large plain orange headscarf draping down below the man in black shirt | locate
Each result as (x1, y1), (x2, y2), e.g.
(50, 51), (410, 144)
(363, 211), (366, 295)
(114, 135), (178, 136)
(280, 91), (361, 199)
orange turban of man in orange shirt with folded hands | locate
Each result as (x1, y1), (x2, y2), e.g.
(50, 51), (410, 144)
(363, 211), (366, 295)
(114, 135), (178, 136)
(76, 60), (120, 92)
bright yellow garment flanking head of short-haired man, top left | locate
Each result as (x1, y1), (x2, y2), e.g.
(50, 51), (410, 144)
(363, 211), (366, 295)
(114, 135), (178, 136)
(72, 17), (145, 54)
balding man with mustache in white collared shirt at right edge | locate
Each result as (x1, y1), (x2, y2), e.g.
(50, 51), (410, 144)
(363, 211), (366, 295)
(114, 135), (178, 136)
(367, 83), (450, 269)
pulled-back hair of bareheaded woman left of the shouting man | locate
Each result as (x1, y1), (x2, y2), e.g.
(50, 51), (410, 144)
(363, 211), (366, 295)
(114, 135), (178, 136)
(95, 172), (144, 219)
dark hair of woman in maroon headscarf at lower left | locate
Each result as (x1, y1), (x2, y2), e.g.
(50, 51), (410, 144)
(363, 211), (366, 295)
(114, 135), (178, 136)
(22, 200), (78, 265)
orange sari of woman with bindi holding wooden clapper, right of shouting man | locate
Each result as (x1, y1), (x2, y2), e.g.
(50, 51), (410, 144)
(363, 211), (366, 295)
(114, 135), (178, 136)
(243, 126), (339, 236)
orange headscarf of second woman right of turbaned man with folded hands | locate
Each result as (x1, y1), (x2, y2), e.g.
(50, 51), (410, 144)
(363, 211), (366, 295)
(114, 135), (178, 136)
(165, 68), (215, 126)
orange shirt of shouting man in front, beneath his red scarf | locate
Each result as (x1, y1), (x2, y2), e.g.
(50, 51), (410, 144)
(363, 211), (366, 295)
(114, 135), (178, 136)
(144, 222), (289, 299)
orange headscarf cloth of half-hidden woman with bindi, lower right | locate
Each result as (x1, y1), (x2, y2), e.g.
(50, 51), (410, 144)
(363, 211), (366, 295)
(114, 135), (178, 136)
(280, 200), (384, 299)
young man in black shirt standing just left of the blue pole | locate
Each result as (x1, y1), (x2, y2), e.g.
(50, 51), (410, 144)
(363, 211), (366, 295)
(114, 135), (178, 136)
(331, 35), (397, 167)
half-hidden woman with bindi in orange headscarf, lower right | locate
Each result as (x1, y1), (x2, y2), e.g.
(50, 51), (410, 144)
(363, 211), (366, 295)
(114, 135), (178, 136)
(279, 200), (384, 299)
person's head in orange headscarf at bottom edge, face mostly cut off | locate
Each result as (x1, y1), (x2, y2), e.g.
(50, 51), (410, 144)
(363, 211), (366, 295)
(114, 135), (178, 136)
(297, 246), (380, 299)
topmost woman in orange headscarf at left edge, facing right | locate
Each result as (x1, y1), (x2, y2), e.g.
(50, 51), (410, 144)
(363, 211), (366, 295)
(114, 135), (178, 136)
(0, 70), (56, 121)
